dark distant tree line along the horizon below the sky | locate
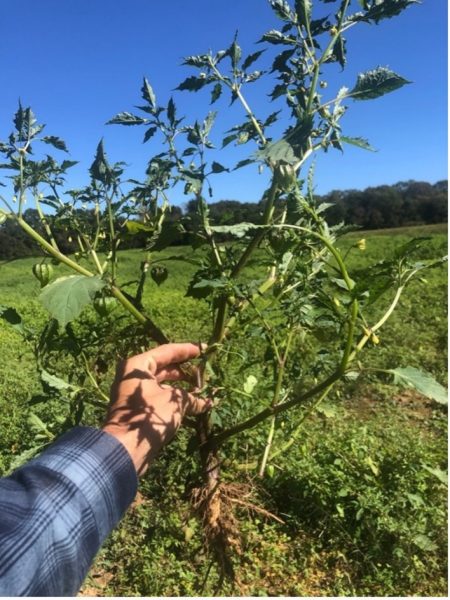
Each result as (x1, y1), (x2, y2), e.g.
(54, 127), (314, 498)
(0, 180), (448, 260)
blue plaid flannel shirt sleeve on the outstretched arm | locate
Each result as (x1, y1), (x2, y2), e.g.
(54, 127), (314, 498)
(0, 427), (137, 596)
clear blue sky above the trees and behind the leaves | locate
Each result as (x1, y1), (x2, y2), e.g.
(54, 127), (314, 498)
(0, 0), (447, 204)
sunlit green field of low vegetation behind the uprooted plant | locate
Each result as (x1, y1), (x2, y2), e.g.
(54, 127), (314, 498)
(0, 225), (447, 596)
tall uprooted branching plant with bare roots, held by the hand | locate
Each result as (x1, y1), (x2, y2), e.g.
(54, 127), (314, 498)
(0, 0), (445, 571)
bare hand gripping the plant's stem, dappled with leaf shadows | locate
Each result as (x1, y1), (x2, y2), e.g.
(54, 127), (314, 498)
(103, 343), (212, 475)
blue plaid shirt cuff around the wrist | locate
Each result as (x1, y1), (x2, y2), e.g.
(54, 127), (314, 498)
(32, 427), (138, 543)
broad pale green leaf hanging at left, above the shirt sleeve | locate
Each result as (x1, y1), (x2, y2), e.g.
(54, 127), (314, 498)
(39, 275), (106, 327)
